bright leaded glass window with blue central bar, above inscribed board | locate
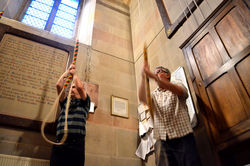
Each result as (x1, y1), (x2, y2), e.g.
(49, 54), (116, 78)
(22, 0), (79, 38)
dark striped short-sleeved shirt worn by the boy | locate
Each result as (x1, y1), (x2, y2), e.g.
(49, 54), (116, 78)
(56, 95), (90, 138)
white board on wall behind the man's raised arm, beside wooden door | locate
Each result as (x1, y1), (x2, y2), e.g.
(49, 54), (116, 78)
(171, 67), (197, 127)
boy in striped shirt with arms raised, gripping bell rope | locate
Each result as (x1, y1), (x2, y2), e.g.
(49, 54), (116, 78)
(50, 64), (90, 166)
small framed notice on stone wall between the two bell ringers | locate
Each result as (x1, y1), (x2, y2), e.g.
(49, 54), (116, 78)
(111, 96), (128, 118)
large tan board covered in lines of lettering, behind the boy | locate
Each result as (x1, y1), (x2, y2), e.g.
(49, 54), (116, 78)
(0, 34), (68, 122)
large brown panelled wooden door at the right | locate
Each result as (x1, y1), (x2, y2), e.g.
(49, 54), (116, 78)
(183, 0), (250, 151)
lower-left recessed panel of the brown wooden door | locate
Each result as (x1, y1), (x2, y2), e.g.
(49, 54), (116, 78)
(207, 73), (246, 132)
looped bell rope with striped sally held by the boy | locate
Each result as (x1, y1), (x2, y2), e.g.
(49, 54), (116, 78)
(41, 40), (79, 145)
